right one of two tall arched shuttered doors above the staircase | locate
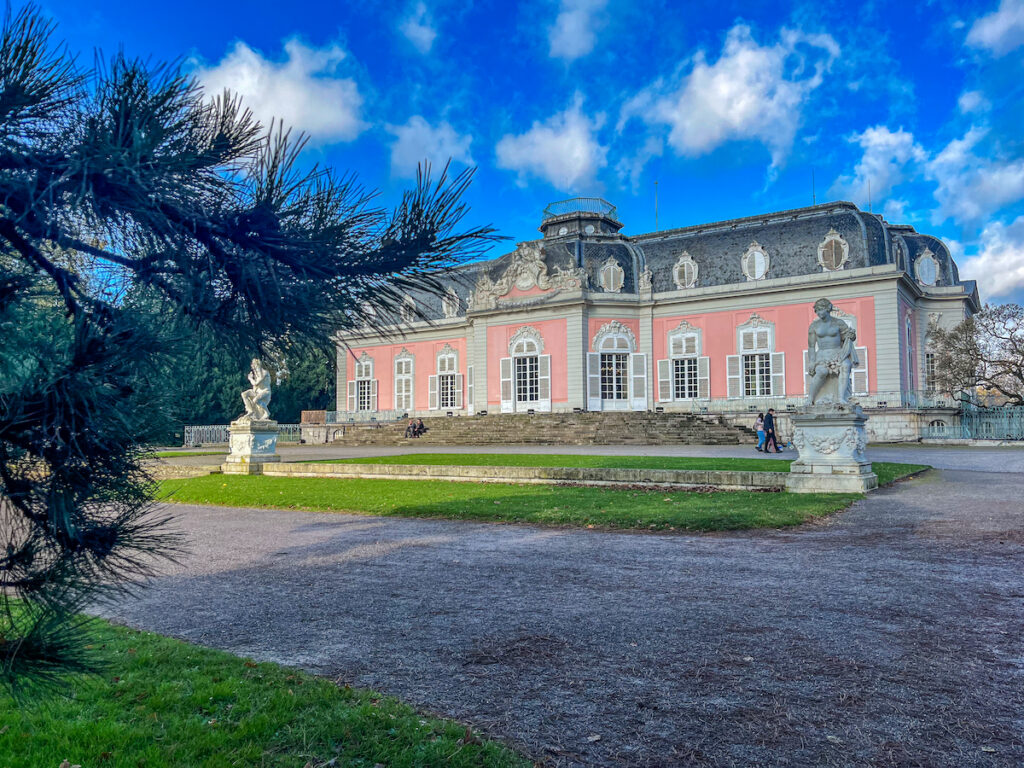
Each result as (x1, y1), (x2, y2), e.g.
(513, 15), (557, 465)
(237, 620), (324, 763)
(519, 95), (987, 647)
(587, 321), (647, 411)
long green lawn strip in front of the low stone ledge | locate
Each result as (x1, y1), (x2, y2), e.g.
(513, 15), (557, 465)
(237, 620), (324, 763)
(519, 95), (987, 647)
(161, 475), (861, 530)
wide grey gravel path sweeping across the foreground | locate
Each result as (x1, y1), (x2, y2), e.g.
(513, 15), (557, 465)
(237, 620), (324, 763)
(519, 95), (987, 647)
(106, 449), (1024, 767)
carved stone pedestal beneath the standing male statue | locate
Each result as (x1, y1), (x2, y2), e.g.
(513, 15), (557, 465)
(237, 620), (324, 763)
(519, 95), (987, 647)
(785, 404), (879, 494)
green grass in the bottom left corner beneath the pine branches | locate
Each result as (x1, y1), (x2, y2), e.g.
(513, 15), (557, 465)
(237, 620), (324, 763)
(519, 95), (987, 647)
(0, 620), (529, 768)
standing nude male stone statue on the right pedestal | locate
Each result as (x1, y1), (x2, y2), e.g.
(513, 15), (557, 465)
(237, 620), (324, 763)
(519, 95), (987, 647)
(807, 299), (860, 406)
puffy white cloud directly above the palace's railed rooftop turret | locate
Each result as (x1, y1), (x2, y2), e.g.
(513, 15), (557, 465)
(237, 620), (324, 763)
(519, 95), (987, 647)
(496, 93), (608, 191)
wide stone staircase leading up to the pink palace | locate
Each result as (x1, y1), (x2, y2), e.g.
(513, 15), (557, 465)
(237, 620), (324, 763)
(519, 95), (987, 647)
(323, 413), (754, 445)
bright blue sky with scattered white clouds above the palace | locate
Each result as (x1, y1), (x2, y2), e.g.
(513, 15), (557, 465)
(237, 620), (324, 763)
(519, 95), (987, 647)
(36, 0), (1024, 303)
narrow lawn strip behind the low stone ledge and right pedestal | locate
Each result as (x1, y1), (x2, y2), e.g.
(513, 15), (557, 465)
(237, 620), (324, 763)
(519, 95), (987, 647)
(310, 454), (929, 485)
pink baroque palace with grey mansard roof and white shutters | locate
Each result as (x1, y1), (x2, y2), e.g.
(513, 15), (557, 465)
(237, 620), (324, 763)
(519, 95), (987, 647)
(337, 198), (979, 428)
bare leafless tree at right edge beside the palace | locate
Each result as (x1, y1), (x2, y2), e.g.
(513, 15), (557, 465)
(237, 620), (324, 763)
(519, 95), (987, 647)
(929, 304), (1024, 406)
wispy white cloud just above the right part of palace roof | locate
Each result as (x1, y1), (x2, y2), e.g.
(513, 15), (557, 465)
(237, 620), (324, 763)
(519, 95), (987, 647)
(828, 125), (927, 208)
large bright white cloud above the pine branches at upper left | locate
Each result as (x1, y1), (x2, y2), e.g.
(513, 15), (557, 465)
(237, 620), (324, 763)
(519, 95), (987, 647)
(196, 39), (367, 143)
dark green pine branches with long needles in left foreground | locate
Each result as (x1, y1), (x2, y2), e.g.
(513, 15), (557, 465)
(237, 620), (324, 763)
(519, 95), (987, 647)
(0, 7), (494, 690)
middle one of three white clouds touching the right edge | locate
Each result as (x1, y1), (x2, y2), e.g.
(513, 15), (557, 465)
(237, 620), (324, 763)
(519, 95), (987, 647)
(927, 127), (1024, 224)
